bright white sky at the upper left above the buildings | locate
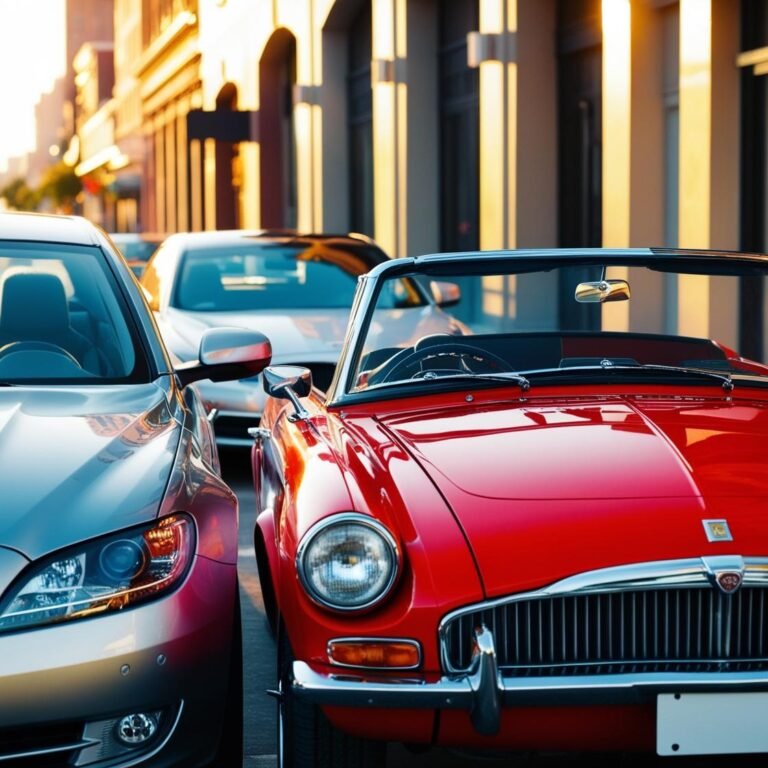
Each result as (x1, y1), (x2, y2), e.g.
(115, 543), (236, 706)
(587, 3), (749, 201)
(0, 0), (65, 172)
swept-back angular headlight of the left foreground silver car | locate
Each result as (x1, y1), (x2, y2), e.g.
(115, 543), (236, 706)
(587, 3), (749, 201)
(0, 515), (195, 631)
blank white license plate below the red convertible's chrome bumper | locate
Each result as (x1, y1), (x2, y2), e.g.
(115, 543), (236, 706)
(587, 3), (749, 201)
(656, 693), (768, 755)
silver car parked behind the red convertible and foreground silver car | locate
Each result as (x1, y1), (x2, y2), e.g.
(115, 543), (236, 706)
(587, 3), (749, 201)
(141, 230), (460, 447)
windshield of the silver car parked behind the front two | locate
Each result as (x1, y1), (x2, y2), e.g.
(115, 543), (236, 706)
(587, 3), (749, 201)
(171, 241), (425, 312)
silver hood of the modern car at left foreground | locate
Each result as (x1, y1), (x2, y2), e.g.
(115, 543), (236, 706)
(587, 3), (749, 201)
(0, 384), (181, 559)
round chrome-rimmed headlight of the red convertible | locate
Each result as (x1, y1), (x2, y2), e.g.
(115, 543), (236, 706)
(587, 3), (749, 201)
(296, 512), (400, 611)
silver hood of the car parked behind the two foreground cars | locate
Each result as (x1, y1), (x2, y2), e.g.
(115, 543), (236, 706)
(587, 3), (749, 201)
(168, 309), (349, 362)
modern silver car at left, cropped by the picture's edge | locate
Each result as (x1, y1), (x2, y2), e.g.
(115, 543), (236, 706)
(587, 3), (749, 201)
(0, 213), (270, 768)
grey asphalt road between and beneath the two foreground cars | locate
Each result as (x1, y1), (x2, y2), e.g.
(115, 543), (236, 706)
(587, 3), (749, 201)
(221, 450), (768, 768)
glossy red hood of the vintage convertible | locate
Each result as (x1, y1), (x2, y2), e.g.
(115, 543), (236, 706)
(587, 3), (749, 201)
(381, 397), (768, 596)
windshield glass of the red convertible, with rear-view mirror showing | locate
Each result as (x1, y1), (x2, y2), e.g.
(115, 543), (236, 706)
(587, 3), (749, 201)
(344, 256), (768, 393)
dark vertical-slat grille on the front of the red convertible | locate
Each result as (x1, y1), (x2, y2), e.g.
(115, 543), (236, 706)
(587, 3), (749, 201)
(441, 584), (768, 675)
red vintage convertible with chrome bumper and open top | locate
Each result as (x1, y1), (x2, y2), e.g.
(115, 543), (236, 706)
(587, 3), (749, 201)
(252, 249), (768, 767)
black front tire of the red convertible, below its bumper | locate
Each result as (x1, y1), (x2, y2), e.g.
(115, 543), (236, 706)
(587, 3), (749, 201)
(277, 626), (386, 768)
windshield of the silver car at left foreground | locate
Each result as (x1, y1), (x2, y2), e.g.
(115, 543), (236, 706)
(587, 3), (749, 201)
(0, 240), (149, 384)
